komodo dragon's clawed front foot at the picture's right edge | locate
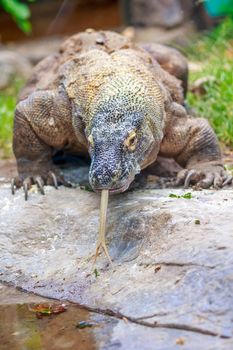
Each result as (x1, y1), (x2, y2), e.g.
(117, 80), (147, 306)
(175, 163), (232, 189)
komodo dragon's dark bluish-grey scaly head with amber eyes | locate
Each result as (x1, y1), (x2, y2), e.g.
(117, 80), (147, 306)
(86, 86), (162, 193)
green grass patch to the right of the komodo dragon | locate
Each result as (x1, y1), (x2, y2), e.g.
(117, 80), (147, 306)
(184, 19), (233, 147)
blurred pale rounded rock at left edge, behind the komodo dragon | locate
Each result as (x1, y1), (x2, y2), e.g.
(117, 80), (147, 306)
(0, 50), (32, 90)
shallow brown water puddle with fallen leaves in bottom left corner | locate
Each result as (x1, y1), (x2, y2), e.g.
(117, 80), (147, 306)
(0, 304), (101, 350)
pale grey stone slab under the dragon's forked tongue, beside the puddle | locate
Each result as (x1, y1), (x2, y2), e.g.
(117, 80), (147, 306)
(0, 166), (233, 350)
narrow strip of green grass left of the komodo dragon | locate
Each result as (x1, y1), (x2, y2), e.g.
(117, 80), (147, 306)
(0, 80), (23, 158)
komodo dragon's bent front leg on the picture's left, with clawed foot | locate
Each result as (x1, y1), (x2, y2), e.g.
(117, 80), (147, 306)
(12, 91), (69, 199)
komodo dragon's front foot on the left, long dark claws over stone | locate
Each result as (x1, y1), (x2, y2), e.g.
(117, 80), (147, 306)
(11, 171), (71, 200)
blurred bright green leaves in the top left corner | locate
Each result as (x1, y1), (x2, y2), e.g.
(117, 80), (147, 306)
(0, 0), (35, 34)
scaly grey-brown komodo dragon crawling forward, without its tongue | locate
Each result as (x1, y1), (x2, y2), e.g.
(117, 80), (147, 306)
(12, 30), (231, 199)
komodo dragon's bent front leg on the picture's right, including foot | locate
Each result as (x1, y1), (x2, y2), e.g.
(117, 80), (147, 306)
(160, 110), (232, 188)
